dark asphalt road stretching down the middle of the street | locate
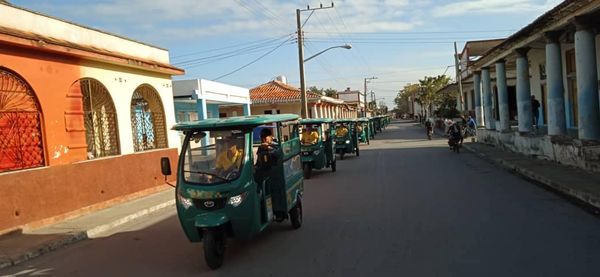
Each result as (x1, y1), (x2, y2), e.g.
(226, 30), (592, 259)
(0, 122), (600, 276)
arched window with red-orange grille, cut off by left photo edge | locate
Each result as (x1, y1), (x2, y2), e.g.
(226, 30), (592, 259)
(0, 67), (44, 172)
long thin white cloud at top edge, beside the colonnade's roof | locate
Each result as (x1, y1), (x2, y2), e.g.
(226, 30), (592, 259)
(432, 0), (562, 17)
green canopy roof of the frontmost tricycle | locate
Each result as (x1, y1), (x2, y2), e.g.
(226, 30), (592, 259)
(172, 114), (298, 131)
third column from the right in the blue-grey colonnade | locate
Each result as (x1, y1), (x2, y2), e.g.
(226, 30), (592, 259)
(516, 47), (533, 133)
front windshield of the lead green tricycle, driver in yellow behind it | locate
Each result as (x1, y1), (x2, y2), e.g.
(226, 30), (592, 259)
(183, 130), (246, 185)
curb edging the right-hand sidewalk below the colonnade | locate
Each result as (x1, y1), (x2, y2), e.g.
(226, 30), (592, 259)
(463, 144), (600, 210)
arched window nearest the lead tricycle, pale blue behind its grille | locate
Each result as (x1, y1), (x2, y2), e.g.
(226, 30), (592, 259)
(131, 85), (167, 152)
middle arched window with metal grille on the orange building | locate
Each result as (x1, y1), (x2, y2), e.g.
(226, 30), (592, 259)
(73, 78), (120, 159)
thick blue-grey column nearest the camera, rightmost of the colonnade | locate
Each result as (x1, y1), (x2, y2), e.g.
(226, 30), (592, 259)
(575, 18), (600, 140)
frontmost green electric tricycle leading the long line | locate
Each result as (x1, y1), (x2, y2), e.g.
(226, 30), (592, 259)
(161, 114), (304, 269)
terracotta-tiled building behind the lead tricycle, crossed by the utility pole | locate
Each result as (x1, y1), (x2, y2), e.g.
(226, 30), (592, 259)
(250, 76), (353, 118)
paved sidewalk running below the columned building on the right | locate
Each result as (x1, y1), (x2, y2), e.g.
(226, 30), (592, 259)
(463, 139), (600, 212)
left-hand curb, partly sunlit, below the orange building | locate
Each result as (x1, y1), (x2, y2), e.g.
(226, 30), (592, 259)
(0, 199), (175, 269)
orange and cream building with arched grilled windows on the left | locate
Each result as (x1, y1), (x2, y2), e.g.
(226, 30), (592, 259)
(0, 3), (183, 234)
